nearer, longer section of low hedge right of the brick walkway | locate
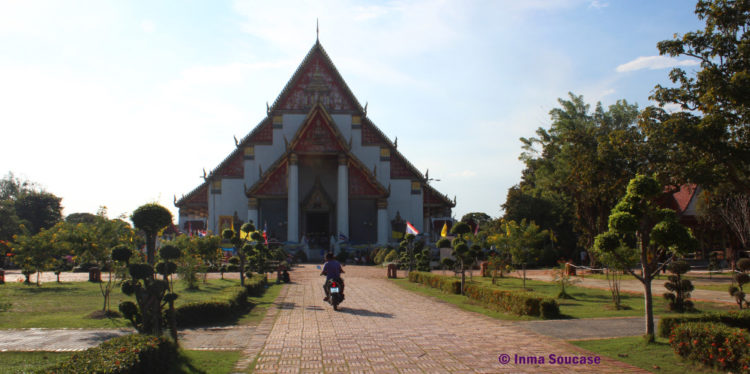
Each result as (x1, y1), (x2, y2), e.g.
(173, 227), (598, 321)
(465, 284), (560, 319)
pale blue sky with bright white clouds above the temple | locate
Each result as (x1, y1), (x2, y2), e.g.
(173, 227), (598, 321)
(0, 0), (702, 219)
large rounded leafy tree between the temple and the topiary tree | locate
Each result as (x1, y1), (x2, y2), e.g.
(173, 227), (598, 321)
(516, 93), (647, 256)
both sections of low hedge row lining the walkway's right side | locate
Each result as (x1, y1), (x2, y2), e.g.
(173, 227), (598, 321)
(409, 271), (560, 318)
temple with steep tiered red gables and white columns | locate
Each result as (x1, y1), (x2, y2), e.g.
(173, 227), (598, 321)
(175, 41), (455, 258)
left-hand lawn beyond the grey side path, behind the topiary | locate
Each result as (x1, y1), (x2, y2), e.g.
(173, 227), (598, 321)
(0, 279), (254, 329)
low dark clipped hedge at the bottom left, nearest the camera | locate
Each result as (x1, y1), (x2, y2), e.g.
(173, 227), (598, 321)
(37, 334), (177, 374)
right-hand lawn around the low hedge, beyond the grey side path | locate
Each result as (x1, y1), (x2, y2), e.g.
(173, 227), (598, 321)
(395, 277), (733, 320)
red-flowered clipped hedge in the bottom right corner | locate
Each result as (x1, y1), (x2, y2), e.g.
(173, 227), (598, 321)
(669, 322), (750, 373)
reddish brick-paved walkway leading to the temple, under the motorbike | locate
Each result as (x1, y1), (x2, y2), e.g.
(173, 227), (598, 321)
(237, 265), (642, 373)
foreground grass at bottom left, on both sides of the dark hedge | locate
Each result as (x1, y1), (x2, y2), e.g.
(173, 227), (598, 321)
(0, 350), (242, 374)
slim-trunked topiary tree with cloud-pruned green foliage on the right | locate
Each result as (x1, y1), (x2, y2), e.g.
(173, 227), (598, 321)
(593, 175), (697, 341)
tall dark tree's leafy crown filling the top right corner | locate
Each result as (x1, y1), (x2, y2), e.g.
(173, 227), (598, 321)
(641, 0), (750, 193)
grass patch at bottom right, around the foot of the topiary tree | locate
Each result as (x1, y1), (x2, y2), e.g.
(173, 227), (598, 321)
(569, 336), (720, 374)
